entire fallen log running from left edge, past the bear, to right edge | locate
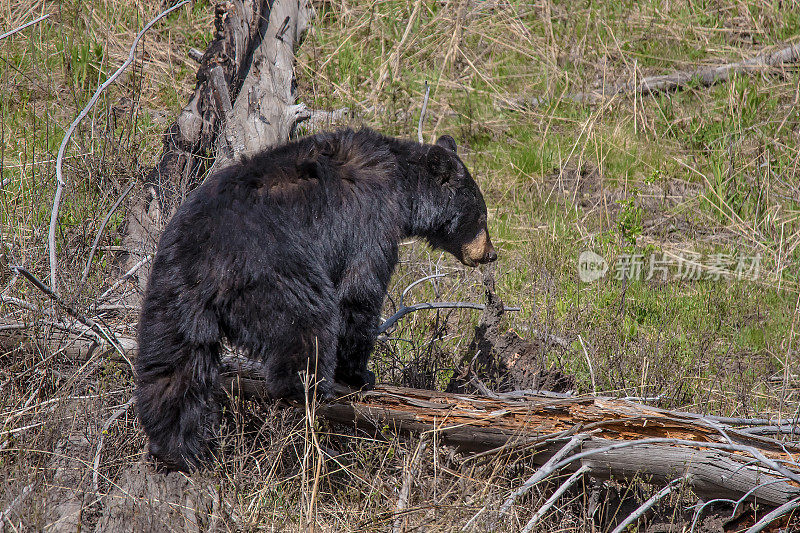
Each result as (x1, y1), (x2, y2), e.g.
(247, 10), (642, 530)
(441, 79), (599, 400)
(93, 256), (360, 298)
(0, 321), (800, 507)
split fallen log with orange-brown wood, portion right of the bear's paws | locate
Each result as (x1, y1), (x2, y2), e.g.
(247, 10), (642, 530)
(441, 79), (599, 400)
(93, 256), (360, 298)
(316, 383), (800, 506)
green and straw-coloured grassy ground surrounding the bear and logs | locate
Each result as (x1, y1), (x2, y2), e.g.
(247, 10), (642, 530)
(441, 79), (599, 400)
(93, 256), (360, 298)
(0, 0), (800, 531)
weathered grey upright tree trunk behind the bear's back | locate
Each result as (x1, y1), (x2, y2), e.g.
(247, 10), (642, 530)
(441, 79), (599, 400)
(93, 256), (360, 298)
(123, 0), (312, 300)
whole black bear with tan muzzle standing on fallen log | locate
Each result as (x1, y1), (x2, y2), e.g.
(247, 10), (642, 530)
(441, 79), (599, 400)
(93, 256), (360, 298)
(136, 129), (497, 471)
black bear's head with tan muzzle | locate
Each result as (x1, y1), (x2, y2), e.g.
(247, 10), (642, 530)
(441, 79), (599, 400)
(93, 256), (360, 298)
(426, 135), (497, 267)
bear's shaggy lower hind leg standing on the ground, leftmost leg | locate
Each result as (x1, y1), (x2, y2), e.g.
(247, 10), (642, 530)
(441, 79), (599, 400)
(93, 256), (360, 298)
(136, 328), (220, 472)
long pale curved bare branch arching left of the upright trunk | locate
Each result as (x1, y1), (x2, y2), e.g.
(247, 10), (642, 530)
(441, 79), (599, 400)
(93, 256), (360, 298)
(47, 0), (190, 292)
